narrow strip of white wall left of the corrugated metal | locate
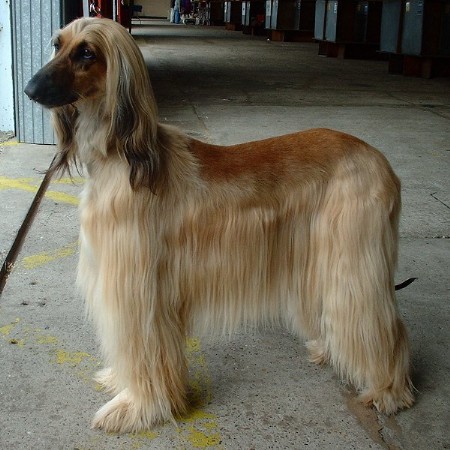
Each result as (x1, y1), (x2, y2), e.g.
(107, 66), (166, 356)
(0, 0), (14, 131)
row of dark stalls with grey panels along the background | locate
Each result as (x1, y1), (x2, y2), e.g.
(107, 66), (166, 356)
(193, 0), (450, 76)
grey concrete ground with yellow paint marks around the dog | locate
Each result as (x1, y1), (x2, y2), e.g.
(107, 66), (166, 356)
(0, 23), (450, 450)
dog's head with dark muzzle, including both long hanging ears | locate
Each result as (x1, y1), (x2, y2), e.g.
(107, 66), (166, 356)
(25, 18), (161, 190)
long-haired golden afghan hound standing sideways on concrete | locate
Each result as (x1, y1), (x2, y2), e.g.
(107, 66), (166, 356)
(25, 18), (413, 432)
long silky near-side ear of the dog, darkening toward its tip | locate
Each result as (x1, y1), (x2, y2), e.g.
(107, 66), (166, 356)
(106, 31), (162, 192)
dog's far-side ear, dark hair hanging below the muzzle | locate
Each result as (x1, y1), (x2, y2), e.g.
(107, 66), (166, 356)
(50, 105), (79, 175)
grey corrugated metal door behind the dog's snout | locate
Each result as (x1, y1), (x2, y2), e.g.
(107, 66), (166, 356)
(11, 0), (61, 144)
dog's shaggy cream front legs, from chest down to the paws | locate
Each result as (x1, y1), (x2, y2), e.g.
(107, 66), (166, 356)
(77, 190), (188, 432)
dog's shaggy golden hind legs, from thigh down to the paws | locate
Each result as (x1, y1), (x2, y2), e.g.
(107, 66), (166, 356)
(309, 163), (413, 414)
